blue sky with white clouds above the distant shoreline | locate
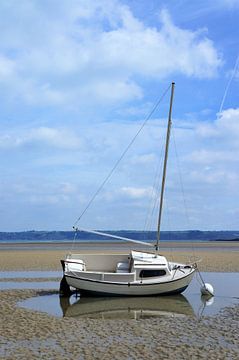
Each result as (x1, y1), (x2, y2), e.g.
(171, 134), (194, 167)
(0, 0), (239, 231)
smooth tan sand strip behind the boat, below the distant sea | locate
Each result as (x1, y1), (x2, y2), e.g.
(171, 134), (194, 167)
(0, 242), (239, 272)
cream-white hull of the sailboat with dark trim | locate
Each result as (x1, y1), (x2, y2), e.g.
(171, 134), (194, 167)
(65, 269), (195, 296)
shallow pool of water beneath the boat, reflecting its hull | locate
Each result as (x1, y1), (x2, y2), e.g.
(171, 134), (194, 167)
(15, 273), (239, 319)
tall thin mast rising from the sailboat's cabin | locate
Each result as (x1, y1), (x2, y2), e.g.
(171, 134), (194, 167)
(155, 82), (175, 253)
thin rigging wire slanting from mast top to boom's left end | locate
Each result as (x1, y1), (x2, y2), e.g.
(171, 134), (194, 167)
(73, 84), (171, 229)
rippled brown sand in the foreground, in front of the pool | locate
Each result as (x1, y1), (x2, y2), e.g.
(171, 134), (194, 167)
(0, 290), (239, 360)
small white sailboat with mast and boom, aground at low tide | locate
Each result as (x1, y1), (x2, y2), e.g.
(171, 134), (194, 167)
(60, 83), (197, 296)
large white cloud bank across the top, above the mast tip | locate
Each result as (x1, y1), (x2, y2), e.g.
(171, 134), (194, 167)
(0, 0), (222, 106)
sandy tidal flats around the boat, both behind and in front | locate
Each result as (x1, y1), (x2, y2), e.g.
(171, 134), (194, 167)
(0, 243), (239, 360)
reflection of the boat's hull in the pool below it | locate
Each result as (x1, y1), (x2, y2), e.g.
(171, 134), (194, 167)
(60, 295), (194, 319)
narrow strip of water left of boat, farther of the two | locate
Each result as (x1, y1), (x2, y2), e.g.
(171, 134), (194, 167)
(0, 270), (62, 279)
